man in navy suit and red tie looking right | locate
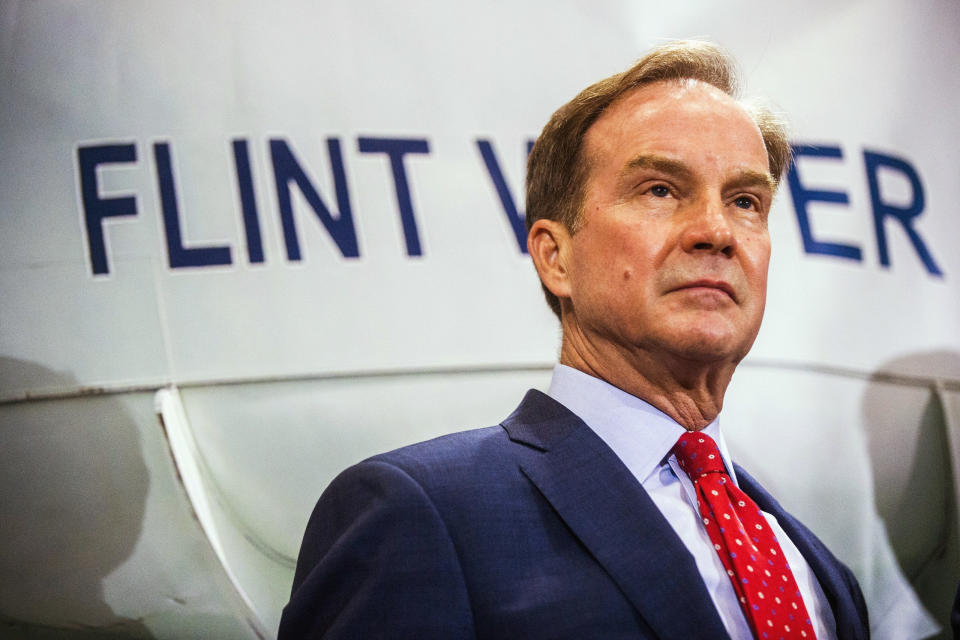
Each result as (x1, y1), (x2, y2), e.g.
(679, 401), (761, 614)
(280, 42), (868, 638)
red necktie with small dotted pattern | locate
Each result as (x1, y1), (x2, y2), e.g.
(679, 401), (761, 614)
(673, 431), (816, 640)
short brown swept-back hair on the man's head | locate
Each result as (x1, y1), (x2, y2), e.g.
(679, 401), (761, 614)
(526, 40), (790, 317)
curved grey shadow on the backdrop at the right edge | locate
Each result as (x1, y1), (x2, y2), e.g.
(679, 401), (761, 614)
(862, 352), (960, 638)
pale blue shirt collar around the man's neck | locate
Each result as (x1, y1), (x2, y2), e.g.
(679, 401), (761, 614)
(547, 364), (736, 483)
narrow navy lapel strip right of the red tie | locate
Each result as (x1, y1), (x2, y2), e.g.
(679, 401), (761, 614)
(736, 465), (866, 638)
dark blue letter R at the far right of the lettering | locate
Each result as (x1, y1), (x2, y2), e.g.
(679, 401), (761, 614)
(863, 150), (943, 276)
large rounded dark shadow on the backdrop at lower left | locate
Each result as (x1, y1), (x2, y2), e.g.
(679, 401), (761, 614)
(0, 358), (151, 639)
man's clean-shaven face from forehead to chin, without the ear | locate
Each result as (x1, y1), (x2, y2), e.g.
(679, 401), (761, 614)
(566, 81), (774, 362)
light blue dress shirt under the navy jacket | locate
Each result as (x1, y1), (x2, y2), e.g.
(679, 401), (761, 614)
(547, 364), (836, 640)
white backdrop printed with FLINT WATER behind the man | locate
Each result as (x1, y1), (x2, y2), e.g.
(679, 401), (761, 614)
(0, 0), (960, 637)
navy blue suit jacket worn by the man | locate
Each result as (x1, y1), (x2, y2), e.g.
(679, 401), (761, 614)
(280, 391), (868, 640)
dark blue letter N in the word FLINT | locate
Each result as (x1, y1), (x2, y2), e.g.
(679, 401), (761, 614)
(270, 138), (360, 261)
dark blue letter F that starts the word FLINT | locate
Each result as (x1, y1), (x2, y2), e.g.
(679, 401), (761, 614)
(77, 144), (137, 275)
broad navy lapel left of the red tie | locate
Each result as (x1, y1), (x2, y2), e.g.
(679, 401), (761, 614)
(503, 391), (728, 639)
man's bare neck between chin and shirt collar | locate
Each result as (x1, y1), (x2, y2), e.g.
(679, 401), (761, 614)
(560, 333), (736, 431)
